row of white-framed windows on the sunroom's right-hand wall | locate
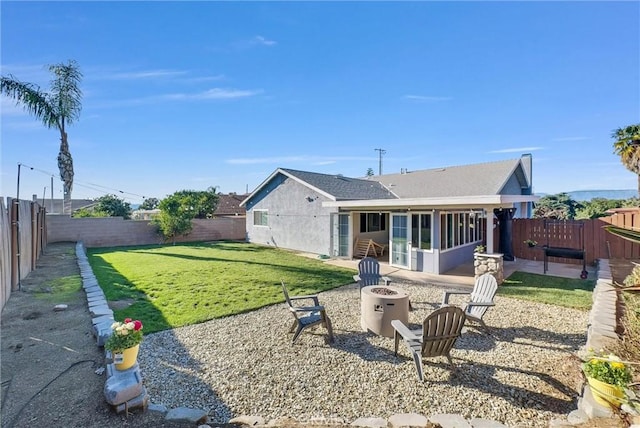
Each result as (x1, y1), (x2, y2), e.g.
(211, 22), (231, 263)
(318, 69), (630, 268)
(440, 211), (484, 250)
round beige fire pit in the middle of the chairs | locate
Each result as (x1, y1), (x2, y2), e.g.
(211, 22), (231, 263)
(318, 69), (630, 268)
(360, 285), (409, 337)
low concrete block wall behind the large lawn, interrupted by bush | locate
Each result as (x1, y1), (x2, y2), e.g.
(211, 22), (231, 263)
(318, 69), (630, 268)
(47, 215), (246, 248)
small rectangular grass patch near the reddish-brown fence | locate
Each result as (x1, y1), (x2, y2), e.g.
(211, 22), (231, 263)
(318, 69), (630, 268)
(498, 272), (595, 310)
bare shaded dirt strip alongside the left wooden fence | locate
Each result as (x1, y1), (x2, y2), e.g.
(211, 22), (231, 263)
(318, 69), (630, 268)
(0, 243), (194, 428)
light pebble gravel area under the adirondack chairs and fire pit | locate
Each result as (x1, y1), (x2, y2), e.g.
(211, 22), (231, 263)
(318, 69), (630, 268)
(139, 283), (588, 427)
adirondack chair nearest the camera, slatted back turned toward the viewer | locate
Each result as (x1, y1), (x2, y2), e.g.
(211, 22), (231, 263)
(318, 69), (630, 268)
(391, 306), (465, 381)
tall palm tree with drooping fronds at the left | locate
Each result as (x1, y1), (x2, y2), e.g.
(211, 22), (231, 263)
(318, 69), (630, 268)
(0, 61), (82, 214)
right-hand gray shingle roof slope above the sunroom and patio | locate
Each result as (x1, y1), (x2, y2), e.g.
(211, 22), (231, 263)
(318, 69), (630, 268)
(371, 159), (526, 198)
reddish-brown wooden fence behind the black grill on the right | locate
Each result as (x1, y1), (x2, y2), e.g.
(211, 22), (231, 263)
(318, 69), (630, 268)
(504, 210), (640, 264)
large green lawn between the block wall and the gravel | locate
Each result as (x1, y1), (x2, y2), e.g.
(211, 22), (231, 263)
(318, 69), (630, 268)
(87, 242), (355, 333)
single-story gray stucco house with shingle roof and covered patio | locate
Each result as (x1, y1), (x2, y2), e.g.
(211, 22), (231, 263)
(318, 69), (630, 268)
(241, 154), (538, 274)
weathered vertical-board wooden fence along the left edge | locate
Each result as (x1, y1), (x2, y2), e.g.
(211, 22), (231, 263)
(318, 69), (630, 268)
(0, 198), (47, 308)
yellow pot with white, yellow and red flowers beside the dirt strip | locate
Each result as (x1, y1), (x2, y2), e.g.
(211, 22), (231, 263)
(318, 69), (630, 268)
(104, 318), (142, 370)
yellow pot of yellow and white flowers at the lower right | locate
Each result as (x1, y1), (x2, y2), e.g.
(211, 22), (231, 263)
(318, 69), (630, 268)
(582, 352), (632, 407)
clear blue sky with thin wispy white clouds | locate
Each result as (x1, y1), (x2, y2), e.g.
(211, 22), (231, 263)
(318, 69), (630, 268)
(0, 1), (640, 203)
